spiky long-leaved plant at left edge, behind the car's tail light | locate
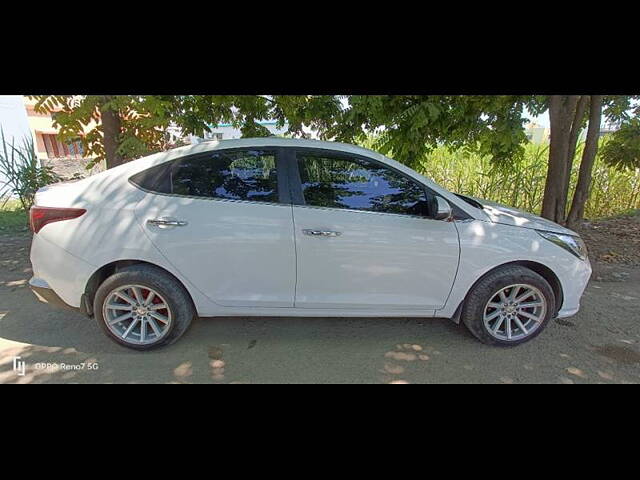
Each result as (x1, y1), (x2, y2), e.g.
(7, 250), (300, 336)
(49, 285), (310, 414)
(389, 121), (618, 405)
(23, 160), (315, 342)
(0, 130), (59, 210)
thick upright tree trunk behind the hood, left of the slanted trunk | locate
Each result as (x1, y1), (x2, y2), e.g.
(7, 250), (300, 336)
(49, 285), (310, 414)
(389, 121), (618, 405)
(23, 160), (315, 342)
(542, 95), (578, 222)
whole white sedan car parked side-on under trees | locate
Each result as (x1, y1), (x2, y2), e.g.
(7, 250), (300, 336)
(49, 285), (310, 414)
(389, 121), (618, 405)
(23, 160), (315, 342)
(30, 138), (591, 350)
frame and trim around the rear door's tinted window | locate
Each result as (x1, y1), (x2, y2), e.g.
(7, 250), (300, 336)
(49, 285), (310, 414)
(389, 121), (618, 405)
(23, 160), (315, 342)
(128, 147), (291, 206)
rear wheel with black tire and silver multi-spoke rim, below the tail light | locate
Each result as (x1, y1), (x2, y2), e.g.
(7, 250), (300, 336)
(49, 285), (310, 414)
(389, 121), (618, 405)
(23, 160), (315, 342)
(93, 265), (195, 350)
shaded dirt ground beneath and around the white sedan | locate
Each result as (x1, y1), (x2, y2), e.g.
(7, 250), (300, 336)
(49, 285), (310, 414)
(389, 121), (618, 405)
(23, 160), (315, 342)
(0, 217), (640, 384)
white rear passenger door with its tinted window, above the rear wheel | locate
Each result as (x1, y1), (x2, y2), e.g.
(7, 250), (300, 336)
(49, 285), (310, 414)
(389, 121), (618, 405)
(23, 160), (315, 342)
(132, 147), (296, 307)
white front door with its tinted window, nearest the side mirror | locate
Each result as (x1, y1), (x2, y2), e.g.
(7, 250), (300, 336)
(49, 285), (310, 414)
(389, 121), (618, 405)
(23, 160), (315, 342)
(291, 150), (459, 314)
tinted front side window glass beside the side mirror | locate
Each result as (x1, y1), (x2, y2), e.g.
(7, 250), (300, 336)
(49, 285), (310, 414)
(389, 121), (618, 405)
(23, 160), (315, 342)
(298, 154), (435, 216)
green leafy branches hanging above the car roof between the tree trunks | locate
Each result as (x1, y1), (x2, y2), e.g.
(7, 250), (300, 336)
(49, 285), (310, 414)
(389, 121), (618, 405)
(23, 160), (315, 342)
(173, 95), (546, 171)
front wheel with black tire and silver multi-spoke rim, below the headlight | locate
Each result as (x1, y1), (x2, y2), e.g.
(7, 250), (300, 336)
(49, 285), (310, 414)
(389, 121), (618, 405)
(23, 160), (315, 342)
(462, 265), (556, 346)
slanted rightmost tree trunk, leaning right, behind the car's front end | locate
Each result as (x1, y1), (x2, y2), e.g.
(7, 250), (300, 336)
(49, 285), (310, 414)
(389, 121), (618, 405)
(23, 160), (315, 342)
(567, 95), (602, 228)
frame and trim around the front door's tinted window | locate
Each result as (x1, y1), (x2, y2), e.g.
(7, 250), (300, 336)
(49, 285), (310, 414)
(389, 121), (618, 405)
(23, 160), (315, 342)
(285, 147), (441, 221)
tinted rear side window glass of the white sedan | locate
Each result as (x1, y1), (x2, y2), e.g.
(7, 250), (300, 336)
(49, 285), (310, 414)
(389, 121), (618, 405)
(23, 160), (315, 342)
(131, 150), (278, 202)
